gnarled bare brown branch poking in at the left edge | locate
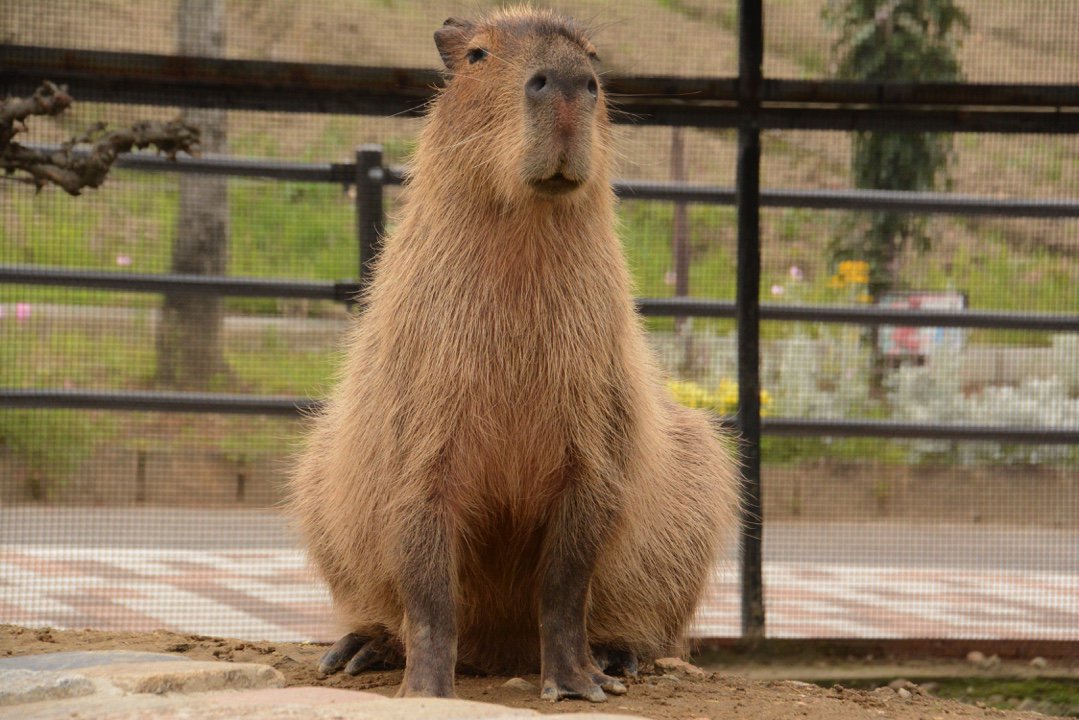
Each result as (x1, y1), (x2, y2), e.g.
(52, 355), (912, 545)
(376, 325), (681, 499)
(0, 81), (199, 195)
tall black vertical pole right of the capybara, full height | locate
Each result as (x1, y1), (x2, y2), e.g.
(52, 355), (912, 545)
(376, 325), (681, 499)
(736, 0), (764, 643)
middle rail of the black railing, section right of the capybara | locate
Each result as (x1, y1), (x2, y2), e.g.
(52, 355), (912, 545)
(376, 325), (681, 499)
(637, 298), (1079, 332)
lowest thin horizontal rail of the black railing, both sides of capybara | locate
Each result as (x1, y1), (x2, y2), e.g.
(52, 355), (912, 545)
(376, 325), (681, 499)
(0, 389), (1079, 445)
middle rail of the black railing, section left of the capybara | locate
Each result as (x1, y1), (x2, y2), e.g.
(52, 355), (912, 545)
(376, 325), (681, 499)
(0, 266), (351, 300)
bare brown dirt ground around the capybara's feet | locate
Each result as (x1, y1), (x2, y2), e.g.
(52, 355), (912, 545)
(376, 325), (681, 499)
(0, 625), (1074, 720)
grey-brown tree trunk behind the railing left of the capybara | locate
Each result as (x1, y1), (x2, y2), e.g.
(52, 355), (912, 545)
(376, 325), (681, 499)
(156, 0), (229, 390)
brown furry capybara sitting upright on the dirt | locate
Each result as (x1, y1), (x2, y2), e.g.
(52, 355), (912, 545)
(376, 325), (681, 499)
(290, 9), (737, 702)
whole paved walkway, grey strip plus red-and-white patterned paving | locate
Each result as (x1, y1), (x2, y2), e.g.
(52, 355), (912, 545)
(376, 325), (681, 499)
(0, 508), (1079, 642)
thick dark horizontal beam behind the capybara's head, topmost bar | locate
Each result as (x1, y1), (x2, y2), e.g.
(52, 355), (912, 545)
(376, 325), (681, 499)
(0, 45), (1079, 134)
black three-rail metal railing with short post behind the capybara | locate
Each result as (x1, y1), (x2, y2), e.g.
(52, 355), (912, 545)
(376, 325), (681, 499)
(0, 146), (1079, 425)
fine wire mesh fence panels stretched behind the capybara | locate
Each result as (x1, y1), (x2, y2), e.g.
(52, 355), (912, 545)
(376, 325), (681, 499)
(0, 0), (1079, 641)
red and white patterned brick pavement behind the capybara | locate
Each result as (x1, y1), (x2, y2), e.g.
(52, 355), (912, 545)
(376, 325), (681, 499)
(0, 543), (1079, 642)
